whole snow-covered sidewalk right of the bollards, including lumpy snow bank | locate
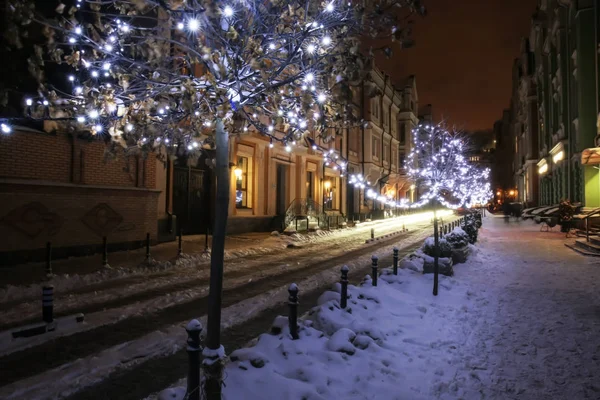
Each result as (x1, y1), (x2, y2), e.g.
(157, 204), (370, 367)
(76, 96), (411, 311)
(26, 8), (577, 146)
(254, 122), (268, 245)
(161, 217), (600, 400)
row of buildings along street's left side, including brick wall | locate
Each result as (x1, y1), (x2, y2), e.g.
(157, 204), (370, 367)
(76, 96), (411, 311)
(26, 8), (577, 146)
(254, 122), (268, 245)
(0, 67), (418, 263)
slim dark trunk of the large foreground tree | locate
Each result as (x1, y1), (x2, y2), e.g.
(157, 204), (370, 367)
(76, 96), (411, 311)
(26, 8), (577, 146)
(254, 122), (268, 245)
(206, 119), (231, 399)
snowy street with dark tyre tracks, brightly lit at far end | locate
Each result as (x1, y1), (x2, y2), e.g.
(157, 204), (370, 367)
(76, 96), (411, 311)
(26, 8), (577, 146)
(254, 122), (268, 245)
(0, 218), (431, 399)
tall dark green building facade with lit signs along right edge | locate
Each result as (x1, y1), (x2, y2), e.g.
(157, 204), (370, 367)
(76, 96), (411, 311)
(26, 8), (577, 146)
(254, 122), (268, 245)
(496, 0), (600, 207)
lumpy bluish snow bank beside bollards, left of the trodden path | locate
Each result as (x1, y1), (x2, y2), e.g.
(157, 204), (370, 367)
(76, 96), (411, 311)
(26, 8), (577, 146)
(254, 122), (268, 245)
(158, 262), (476, 400)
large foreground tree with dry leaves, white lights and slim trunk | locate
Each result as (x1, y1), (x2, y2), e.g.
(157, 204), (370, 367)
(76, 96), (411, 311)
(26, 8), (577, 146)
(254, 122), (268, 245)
(1, 0), (424, 396)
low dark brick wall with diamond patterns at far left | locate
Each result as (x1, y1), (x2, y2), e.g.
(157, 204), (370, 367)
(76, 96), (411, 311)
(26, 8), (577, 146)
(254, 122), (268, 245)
(0, 127), (160, 263)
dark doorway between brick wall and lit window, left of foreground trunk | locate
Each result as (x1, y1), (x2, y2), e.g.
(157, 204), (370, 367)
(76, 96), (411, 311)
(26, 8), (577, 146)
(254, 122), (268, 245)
(173, 166), (212, 235)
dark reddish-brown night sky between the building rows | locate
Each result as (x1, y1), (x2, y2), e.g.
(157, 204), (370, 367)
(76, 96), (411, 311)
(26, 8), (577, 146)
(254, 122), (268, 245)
(378, 0), (537, 131)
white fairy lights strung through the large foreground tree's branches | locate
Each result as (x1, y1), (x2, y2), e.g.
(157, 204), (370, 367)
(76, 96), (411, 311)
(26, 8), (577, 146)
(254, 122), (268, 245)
(0, 0), (351, 173)
